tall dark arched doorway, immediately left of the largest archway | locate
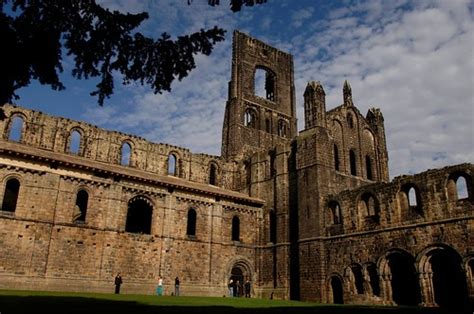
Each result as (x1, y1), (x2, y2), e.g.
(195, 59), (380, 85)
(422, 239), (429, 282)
(381, 250), (421, 305)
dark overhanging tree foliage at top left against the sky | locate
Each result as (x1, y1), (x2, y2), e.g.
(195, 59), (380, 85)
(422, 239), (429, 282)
(0, 0), (266, 110)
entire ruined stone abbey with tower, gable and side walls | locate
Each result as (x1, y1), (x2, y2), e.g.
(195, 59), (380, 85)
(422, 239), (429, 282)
(0, 31), (474, 307)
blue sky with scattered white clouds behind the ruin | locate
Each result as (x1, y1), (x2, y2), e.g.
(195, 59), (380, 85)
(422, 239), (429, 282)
(11, 0), (474, 177)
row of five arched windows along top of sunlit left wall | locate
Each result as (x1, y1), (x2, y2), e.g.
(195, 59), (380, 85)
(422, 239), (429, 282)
(7, 115), (218, 185)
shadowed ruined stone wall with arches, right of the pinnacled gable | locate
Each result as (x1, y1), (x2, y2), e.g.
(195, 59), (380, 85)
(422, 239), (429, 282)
(300, 164), (474, 305)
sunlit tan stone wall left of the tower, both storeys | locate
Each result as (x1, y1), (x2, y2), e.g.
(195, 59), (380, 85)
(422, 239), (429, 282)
(0, 105), (263, 296)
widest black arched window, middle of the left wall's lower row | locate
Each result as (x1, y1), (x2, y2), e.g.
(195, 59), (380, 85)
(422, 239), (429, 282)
(125, 196), (153, 234)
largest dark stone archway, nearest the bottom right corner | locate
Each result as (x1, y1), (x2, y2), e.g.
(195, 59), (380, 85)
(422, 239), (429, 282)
(418, 245), (469, 309)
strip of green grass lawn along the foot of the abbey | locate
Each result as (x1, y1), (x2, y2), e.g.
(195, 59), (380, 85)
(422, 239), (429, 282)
(0, 290), (461, 314)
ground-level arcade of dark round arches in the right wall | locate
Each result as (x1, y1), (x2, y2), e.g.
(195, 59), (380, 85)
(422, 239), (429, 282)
(327, 245), (474, 309)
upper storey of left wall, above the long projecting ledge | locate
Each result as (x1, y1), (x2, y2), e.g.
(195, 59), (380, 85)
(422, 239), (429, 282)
(0, 104), (235, 189)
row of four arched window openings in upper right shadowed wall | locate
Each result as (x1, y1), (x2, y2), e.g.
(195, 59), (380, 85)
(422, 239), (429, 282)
(328, 173), (470, 225)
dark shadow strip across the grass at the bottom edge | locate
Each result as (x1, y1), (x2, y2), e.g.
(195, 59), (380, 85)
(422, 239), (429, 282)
(0, 295), (471, 314)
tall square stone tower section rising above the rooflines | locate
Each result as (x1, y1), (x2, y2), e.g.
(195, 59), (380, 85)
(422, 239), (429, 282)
(222, 31), (296, 159)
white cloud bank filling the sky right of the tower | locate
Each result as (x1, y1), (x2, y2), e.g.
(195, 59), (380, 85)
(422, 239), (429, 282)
(290, 2), (474, 175)
